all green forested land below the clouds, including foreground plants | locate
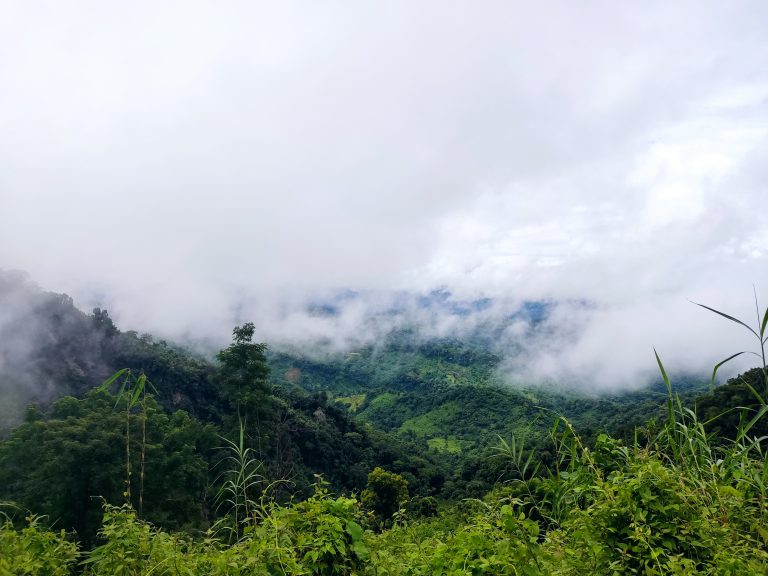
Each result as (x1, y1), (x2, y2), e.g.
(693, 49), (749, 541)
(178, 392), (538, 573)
(0, 273), (768, 575)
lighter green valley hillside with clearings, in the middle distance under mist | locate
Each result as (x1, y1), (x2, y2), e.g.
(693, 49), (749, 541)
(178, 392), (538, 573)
(269, 338), (708, 498)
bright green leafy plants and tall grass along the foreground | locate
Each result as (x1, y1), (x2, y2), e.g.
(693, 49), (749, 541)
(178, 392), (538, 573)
(0, 366), (768, 576)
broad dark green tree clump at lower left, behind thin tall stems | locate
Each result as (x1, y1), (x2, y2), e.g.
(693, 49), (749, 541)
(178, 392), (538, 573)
(0, 390), (217, 545)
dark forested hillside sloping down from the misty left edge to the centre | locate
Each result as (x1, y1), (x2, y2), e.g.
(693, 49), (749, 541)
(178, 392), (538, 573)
(0, 275), (449, 541)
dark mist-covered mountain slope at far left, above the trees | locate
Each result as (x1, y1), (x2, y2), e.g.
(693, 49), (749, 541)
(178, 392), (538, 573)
(0, 271), (218, 430)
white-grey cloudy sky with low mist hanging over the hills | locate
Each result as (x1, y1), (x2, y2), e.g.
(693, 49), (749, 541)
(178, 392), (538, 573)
(0, 0), (768, 388)
